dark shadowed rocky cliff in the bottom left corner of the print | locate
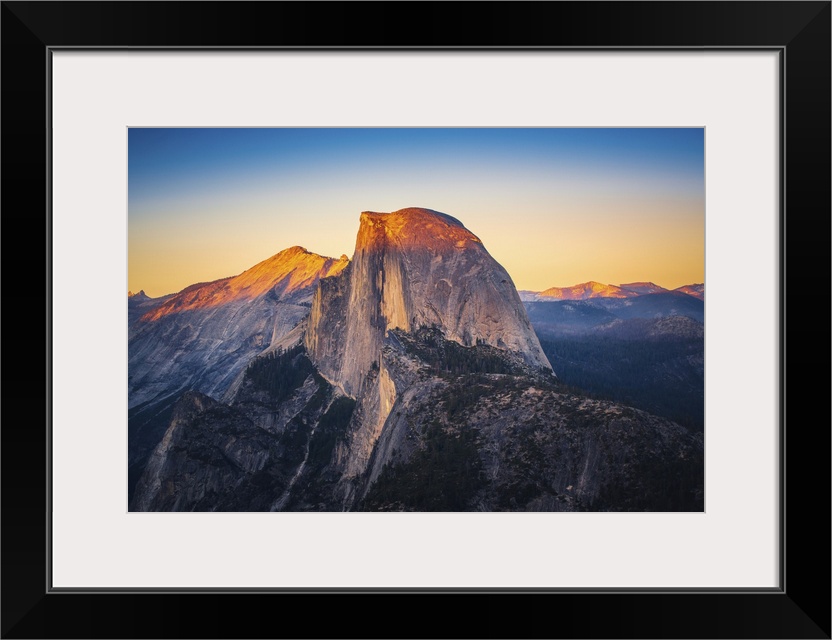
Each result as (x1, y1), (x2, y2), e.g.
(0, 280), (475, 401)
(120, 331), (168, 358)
(131, 347), (355, 511)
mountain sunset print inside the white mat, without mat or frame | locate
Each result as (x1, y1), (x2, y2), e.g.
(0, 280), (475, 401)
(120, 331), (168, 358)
(122, 127), (708, 516)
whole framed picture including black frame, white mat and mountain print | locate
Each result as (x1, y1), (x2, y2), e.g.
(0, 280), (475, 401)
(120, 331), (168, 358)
(2, 2), (830, 638)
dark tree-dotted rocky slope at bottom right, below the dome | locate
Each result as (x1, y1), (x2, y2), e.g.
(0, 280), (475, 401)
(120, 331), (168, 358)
(362, 340), (704, 511)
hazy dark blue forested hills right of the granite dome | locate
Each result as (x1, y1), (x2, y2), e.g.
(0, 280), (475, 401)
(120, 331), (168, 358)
(524, 291), (705, 430)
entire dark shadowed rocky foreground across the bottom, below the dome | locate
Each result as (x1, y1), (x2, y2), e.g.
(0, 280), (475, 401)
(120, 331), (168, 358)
(132, 329), (704, 511)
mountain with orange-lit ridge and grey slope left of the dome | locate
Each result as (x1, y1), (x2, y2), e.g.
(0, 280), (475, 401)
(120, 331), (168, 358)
(128, 247), (349, 408)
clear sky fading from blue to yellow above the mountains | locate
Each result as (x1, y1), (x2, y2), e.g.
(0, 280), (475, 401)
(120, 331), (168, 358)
(128, 128), (705, 297)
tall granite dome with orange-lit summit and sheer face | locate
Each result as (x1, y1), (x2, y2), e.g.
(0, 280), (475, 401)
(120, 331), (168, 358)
(305, 208), (552, 484)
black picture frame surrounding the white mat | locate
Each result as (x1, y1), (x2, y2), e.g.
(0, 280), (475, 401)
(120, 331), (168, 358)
(0, 1), (832, 638)
